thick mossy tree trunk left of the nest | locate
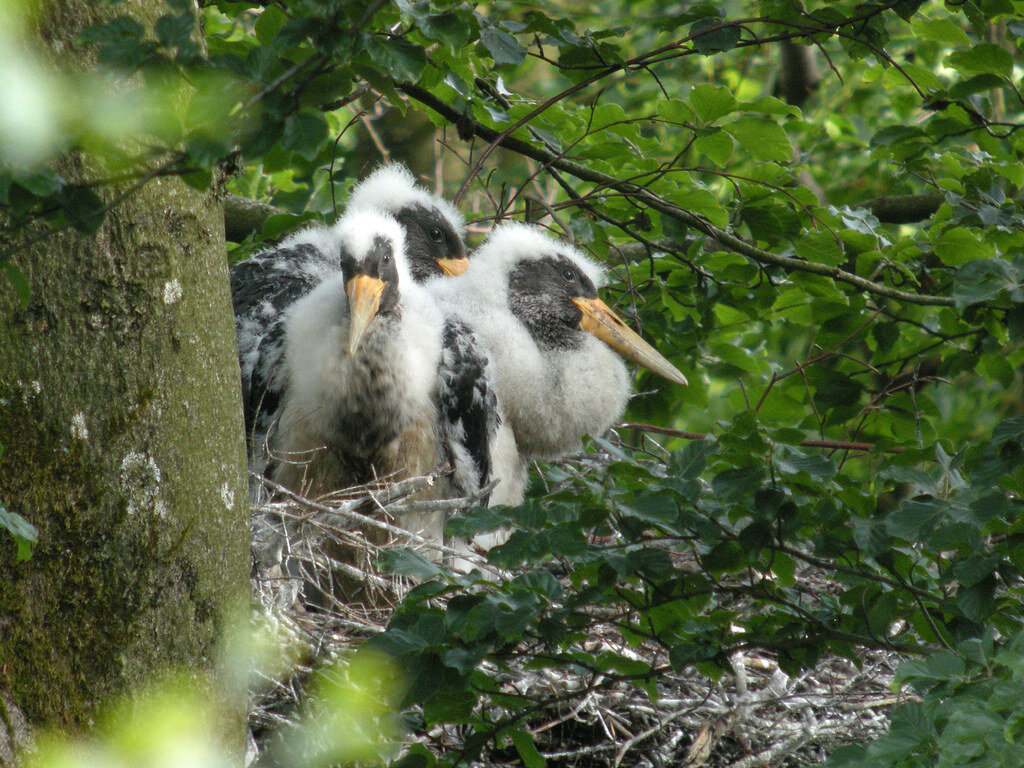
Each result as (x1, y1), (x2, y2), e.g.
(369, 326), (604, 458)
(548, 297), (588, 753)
(0, 0), (249, 765)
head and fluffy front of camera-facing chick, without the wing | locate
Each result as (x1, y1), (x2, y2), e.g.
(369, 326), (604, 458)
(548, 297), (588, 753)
(274, 210), (442, 494)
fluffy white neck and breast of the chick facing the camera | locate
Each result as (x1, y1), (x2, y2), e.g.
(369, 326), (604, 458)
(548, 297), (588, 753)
(276, 274), (441, 489)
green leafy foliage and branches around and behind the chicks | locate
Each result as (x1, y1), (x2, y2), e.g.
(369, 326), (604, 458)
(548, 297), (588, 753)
(6, 0), (1024, 766)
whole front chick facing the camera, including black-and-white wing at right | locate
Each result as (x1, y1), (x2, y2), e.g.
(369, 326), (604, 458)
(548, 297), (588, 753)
(270, 209), (521, 514)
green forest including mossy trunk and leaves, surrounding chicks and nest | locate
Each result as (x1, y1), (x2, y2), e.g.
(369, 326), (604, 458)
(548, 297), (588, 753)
(0, 0), (1024, 766)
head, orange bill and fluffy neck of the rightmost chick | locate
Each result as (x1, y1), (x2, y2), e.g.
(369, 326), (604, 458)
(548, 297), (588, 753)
(428, 223), (686, 459)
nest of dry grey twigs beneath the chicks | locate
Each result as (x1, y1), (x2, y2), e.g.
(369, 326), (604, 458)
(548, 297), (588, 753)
(249, 468), (902, 768)
